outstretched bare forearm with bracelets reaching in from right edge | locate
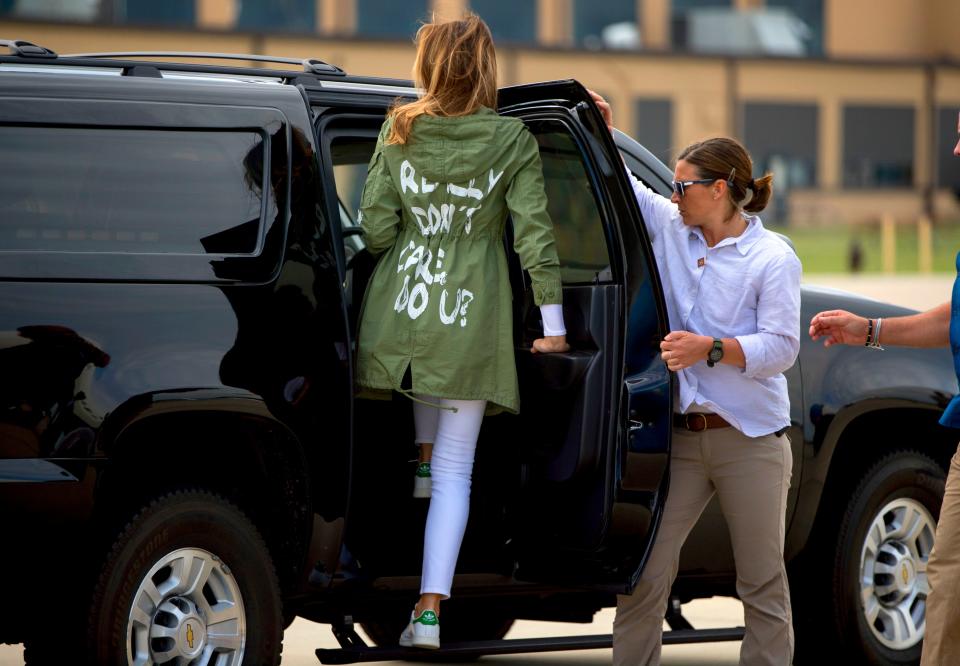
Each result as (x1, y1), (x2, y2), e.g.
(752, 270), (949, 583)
(810, 301), (950, 347)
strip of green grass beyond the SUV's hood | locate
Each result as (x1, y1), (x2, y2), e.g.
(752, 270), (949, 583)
(769, 220), (960, 273)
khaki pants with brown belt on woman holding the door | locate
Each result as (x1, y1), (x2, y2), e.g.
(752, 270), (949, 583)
(613, 428), (793, 666)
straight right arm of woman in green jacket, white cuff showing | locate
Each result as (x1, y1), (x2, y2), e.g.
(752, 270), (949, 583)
(506, 130), (570, 353)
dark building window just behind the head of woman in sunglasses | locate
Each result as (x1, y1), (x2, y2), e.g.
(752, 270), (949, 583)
(743, 102), (819, 221)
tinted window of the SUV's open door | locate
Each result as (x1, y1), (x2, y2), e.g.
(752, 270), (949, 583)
(531, 122), (612, 284)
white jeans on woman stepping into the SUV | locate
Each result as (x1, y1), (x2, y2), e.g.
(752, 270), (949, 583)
(413, 395), (487, 599)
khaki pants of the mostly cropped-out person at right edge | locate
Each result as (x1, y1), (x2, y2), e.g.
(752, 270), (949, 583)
(920, 440), (960, 666)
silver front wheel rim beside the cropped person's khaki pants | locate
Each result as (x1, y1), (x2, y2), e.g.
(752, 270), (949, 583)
(860, 497), (937, 650)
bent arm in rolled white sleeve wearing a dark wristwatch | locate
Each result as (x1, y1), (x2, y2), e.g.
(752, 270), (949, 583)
(660, 252), (801, 378)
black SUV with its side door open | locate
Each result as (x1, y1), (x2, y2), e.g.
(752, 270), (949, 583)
(0, 42), (957, 666)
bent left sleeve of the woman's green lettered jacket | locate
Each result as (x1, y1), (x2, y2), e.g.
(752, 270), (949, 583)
(357, 121), (403, 255)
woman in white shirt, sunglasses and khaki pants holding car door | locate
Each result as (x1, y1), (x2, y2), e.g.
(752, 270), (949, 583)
(591, 93), (801, 666)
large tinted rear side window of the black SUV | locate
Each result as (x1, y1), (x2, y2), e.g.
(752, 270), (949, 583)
(0, 127), (266, 254)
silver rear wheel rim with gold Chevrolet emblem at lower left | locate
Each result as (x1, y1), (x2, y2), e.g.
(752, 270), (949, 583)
(127, 548), (247, 666)
